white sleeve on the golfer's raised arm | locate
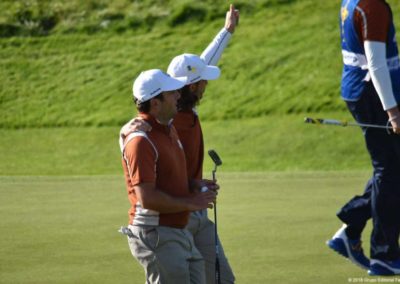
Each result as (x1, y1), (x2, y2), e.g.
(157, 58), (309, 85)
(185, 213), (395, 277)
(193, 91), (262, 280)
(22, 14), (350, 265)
(200, 28), (232, 66)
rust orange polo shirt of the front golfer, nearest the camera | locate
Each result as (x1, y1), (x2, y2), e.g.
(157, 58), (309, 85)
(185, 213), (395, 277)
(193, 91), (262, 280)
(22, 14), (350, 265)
(122, 114), (190, 228)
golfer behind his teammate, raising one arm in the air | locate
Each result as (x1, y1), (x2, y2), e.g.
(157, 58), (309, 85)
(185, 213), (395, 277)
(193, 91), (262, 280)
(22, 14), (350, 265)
(120, 5), (239, 284)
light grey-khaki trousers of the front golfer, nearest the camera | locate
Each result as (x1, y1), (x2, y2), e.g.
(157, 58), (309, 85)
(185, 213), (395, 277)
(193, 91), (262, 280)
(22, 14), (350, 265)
(128, 225), (206, 284)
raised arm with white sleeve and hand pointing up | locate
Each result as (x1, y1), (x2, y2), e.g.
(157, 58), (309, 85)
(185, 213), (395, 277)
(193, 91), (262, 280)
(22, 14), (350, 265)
(200, 4), (239, 66)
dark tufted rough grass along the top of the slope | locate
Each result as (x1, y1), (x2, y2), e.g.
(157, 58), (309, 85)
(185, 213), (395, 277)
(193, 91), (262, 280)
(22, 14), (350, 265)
(0, 0), (302, 37)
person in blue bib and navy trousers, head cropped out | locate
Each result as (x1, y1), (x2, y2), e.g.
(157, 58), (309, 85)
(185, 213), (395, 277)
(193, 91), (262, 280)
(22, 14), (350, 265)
(327, 0), (400, 275)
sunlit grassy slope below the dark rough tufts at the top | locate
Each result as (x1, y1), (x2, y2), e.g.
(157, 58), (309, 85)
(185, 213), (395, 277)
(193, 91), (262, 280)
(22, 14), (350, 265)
(0, 0), (400, 128)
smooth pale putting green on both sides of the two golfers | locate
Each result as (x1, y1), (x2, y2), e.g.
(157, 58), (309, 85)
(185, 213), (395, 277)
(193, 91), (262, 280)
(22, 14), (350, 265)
(0, 172), (400, 284)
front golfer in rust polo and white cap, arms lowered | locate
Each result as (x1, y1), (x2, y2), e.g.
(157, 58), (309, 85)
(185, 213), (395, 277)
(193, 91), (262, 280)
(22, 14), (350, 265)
(120, 69), (215, 284)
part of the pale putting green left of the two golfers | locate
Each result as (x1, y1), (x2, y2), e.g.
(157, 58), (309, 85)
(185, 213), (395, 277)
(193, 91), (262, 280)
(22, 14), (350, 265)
(0, 177), (136, 283)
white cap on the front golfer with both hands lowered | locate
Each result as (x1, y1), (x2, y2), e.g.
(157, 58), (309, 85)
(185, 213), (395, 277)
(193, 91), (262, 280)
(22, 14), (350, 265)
(133, 69), (187, 103)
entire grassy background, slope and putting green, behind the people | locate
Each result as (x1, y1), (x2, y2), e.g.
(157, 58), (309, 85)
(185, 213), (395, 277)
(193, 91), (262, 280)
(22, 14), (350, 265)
(0, 0), (400, 283)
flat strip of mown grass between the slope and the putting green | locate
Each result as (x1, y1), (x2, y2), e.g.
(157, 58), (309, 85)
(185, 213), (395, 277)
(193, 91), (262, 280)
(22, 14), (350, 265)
(0, 113), (370, 175)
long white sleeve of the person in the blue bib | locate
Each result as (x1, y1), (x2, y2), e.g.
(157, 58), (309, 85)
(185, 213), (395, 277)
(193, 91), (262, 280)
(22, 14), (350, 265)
(364, 41), (397, 110)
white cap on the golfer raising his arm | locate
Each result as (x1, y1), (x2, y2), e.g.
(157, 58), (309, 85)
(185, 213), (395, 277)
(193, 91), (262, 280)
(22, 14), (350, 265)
(167, 53), (221, 84)
